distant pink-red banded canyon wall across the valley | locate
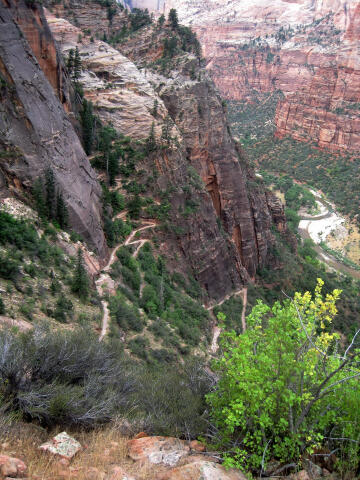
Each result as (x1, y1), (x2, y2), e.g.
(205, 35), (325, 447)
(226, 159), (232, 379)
(134, 0), (360, 151)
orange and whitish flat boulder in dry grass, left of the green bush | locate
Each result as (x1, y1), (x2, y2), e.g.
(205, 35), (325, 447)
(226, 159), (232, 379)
(128, 437), (190, 467)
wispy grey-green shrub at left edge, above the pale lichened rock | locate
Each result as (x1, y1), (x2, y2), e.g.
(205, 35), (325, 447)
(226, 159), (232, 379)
(0, 325), (135, 427)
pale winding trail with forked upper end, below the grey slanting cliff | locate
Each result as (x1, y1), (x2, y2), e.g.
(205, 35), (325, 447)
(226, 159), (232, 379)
(95, 211), (156, 342)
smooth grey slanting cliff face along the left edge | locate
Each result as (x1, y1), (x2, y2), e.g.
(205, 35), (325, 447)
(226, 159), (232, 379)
(0, 2), (106, 257)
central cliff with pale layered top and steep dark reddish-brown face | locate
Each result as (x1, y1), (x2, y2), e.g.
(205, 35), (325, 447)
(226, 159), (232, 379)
(44, 5), (286, 299)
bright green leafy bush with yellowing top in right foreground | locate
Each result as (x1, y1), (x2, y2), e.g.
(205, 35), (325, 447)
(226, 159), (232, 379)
(208, 280), (360, 469)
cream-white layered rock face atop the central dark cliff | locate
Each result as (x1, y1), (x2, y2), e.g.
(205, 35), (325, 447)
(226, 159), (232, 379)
(46, 12), (167, 140)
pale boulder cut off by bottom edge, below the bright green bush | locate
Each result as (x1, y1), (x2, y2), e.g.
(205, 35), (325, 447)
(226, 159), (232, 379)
(158, 460), (246, 480)
